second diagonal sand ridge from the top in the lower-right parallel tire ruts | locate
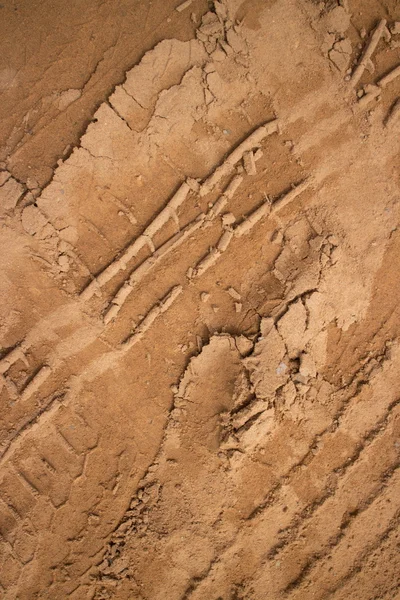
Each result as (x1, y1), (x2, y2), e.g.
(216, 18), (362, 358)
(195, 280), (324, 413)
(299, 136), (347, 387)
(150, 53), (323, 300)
(254, 405), (400, 593)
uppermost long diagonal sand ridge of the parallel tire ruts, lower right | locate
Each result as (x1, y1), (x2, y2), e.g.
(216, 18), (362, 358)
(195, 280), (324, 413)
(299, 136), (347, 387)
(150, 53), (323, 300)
(184, 350), (400, 600)
